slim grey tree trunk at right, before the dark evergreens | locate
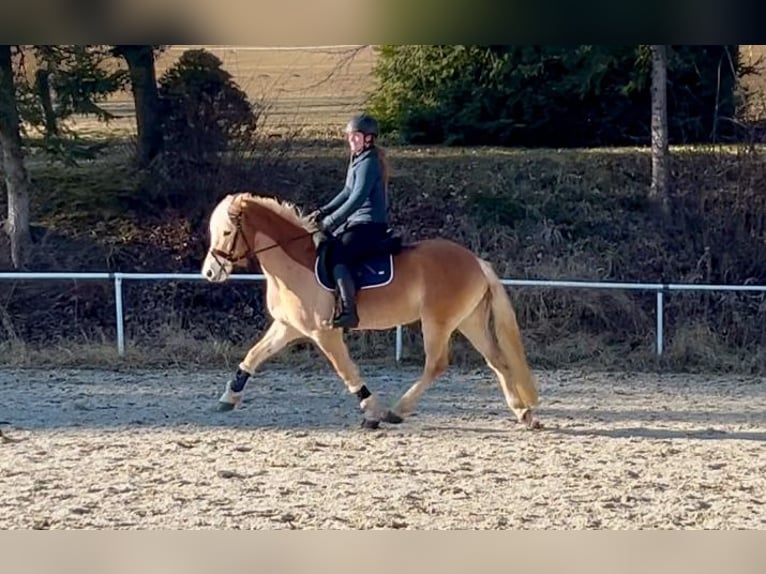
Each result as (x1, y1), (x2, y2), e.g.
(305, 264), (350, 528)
(649, 45), (670, 215)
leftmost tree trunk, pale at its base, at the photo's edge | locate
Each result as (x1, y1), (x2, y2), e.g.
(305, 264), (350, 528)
(0, 45), (30, 269)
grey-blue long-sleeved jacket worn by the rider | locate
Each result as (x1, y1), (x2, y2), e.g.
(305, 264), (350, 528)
(320, 146), (388, 234)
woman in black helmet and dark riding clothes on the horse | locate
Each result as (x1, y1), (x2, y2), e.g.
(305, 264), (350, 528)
(309, 114), (388, 328)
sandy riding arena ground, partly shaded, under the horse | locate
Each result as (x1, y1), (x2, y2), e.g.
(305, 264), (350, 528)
(0, 365), (766, 529)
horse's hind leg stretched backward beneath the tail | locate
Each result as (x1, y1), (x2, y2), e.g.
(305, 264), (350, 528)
(458, 302), (528, 422)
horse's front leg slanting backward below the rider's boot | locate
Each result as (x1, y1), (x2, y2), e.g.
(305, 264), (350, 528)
(312, 329), (385, 429)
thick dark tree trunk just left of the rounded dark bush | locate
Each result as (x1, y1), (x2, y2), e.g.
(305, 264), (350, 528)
(115, 45), (162, 167)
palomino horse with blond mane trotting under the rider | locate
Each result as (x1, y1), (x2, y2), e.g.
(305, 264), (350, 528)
(202, 193), (541, 428)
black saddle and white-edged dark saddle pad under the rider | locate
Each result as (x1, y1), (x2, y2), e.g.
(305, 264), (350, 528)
(314, 229), (405, 291)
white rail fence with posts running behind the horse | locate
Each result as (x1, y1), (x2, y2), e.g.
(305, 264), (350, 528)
(0, 272), (766, 361)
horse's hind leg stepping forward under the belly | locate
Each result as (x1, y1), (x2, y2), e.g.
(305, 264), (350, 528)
(383, 319), (452, 423)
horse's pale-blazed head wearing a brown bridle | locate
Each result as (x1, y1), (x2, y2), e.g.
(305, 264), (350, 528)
(202, 195), (251, 283)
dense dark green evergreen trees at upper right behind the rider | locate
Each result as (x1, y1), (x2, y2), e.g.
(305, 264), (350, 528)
(367, 44), (737, 147)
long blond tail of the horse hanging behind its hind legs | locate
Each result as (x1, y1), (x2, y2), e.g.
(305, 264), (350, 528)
(479, 260), (538, 408)
